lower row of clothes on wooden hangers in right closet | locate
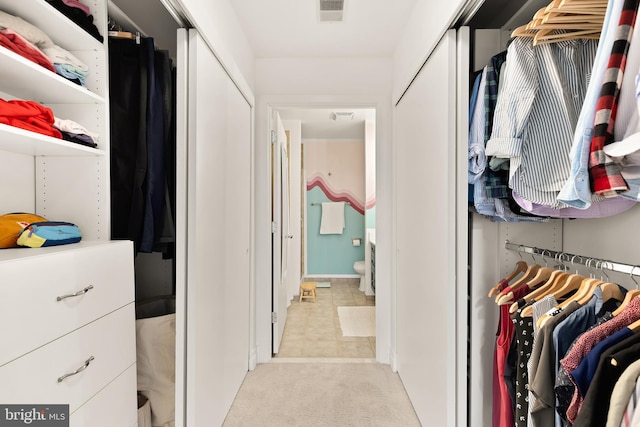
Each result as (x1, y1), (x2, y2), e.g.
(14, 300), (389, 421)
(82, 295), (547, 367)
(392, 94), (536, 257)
(489, 245), (640, 427)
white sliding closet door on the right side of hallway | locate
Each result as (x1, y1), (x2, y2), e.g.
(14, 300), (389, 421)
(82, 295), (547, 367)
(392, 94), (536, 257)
(394, 29), (468, 427)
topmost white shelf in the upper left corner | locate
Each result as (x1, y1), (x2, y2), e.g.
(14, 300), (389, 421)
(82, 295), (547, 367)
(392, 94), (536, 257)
(0, 0), (101, 51)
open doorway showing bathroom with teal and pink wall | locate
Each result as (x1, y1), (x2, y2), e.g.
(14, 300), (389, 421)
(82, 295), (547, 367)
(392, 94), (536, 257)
(271, 107), (376, 360)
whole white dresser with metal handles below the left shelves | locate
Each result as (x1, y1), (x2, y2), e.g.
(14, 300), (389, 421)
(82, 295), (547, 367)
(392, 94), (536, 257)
(0, 242), (136, 427)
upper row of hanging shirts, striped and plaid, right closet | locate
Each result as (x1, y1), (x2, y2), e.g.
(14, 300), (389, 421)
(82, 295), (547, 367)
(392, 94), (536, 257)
(469, 0), (640, 222)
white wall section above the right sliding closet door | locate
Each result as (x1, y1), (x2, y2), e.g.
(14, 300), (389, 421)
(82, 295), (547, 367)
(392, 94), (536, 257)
(393, 0), (466, 103)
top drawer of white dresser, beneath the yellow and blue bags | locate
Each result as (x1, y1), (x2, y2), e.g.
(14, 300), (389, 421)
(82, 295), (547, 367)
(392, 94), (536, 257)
(0, 241), (134, 366)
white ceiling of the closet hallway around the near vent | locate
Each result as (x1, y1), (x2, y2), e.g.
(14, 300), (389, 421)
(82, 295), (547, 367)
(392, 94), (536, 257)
(229, 0), (416, 58)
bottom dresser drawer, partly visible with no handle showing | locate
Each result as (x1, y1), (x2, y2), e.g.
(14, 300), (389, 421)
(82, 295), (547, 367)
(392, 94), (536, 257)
(69, 365), (138, 427)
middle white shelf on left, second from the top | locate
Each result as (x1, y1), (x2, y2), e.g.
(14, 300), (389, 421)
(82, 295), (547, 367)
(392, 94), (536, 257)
(0, 47), (105, 104)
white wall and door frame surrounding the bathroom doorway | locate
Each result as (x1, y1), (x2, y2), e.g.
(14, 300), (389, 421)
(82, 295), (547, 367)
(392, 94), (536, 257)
(255, 58), (392, 363)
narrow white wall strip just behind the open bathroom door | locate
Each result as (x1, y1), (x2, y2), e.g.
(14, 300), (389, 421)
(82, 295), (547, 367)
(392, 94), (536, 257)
(282, 120), (302, 300)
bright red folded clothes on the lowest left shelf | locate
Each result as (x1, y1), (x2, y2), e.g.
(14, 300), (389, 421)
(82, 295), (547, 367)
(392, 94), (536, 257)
(0, 98), (62, 139)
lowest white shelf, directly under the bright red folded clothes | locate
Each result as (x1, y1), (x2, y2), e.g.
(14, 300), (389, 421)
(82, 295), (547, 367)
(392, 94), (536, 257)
(0, 124), (105, 157)
